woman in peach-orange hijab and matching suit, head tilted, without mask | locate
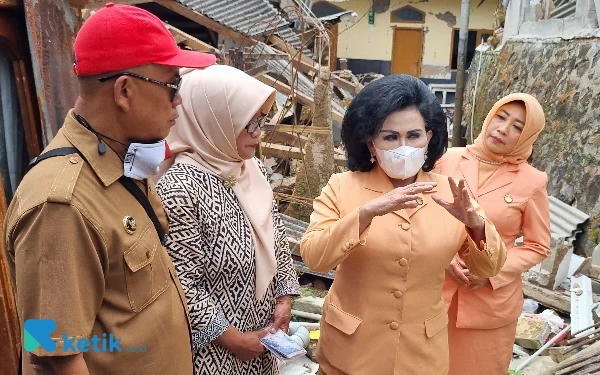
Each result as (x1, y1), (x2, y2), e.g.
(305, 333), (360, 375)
(435, 94), (550, 375)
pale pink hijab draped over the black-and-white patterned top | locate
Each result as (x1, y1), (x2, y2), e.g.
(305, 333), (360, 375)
(161, 65), (277, 300)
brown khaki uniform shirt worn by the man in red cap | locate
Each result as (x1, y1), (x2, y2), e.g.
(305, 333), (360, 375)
(4, 112), (193, 375)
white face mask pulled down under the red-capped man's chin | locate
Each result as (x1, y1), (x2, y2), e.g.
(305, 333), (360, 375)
(123, 140), (170, 180)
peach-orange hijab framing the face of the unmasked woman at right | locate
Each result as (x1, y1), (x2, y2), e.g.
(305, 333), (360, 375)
(467, 93), (546, 164)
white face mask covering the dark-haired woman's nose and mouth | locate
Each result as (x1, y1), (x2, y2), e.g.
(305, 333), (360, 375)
(375, 146), (427, 180)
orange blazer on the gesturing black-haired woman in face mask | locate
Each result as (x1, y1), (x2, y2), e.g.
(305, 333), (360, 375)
(300, 166), (506, 375)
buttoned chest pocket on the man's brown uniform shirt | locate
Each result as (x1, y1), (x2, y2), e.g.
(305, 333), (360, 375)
(123, 225), (169, 312)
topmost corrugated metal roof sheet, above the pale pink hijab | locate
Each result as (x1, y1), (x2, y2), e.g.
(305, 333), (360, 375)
(177, 0), (310, 54)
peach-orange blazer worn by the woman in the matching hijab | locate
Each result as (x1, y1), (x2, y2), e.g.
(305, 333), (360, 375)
(435, 147), (550, 329)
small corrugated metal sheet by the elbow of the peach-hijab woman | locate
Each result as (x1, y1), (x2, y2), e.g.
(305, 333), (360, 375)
(549, 197), (590, 242)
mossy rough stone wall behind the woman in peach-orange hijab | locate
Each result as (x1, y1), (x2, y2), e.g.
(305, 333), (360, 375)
(465, 38), (600, 255)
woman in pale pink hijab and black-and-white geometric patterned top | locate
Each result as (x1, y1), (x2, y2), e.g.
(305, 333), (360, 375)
(157, 65), (299, 375)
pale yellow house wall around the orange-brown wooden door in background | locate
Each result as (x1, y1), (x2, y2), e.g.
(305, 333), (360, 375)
(336, 0), (497, 79)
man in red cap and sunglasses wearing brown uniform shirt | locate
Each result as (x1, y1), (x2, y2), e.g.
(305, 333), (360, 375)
(4, 4), (215, 375)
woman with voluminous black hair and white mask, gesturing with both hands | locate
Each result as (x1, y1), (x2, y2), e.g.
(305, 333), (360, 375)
(300, 75), (506, 375)
